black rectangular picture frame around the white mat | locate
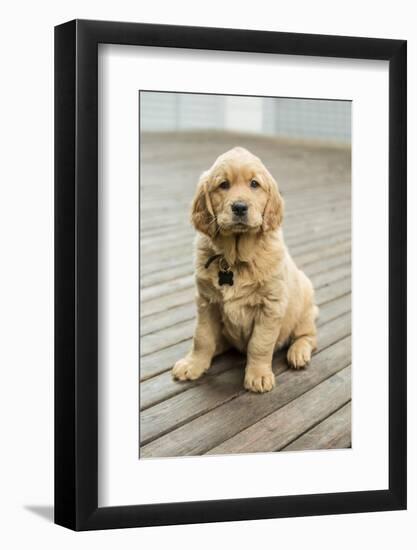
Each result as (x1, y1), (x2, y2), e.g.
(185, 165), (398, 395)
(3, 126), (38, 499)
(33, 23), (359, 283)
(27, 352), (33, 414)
(55, 20), (407, 530)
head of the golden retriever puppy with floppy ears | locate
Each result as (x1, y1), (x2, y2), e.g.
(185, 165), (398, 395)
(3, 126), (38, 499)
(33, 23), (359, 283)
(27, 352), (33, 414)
(192, 147), (283, 237)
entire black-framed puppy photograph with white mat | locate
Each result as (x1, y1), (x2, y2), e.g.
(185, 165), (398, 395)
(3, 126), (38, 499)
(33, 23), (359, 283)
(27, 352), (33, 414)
(55, 20), (406, 530)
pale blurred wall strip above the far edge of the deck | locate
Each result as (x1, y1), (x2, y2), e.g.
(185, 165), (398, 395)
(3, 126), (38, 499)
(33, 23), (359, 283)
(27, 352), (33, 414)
(140, 92), (351, 143)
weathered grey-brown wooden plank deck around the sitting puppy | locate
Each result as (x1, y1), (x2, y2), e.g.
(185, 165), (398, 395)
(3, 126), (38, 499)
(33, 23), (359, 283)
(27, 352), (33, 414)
(140, 132), (351, 458)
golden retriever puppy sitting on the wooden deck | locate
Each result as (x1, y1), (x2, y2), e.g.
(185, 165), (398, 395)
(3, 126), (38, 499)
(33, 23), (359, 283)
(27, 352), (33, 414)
(173, 147), (318, 392)
